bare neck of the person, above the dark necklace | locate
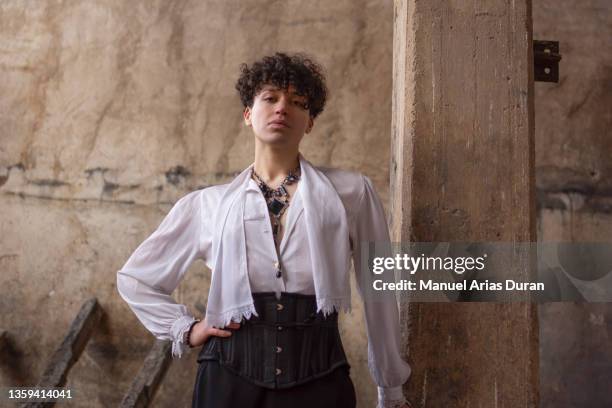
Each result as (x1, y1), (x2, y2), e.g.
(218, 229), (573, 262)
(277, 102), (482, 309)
(253, 143), (299, 185)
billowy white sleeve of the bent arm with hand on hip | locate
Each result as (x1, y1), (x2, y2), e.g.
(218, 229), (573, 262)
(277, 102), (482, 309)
(117, 191), (206, 357)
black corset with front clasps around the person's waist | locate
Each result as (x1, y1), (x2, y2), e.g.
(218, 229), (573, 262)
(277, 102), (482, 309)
(198, 292), (348, 389)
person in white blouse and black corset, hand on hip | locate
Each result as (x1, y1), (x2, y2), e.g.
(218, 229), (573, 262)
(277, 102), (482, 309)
(117, 53), (410, 408)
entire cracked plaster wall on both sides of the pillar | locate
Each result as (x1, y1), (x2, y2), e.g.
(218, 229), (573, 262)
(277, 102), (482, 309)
(0, 0), (612, 406)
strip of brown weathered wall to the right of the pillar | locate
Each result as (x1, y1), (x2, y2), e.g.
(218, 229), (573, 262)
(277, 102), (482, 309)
(533, 0), (612, 408)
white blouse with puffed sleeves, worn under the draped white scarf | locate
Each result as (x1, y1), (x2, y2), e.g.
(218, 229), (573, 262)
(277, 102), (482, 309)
(117, 158), (410, 406)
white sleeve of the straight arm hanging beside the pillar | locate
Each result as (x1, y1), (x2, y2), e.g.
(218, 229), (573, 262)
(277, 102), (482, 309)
(353, 176), (410, 407)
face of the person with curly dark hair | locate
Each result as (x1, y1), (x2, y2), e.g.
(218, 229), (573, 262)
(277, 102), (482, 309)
(244, 85), (314, 147)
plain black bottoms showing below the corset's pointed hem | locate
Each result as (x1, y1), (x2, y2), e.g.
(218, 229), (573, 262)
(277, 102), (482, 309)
(192, 360), (357, 408)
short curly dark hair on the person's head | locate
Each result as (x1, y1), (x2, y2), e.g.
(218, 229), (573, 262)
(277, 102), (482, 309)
(236, 52), (327, 119)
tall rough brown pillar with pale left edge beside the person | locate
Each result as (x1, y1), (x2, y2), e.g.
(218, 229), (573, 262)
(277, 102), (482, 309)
(390, 0), (538, 408)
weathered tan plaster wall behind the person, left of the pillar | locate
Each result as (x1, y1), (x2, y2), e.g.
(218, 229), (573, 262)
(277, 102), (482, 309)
(0, 0), (392, 407)
